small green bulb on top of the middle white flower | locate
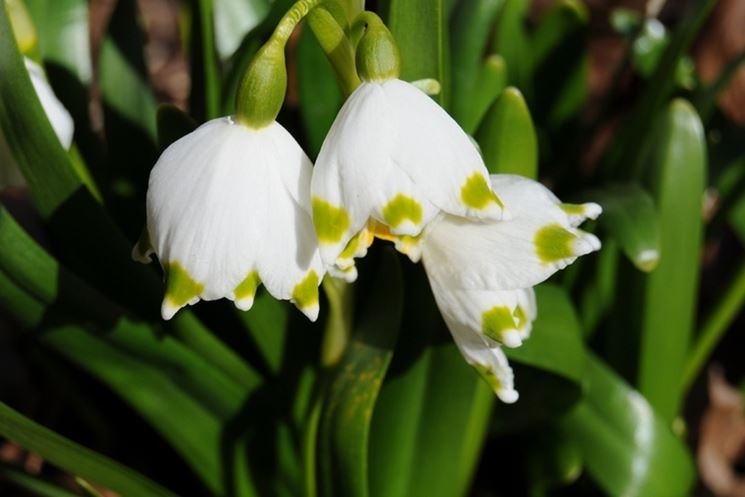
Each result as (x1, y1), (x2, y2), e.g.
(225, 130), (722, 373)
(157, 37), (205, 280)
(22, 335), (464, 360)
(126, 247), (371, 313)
(356, 12), (401, 81)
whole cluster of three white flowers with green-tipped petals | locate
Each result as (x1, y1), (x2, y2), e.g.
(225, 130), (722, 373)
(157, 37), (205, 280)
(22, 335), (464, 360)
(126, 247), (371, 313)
(126, 6), (601, 402)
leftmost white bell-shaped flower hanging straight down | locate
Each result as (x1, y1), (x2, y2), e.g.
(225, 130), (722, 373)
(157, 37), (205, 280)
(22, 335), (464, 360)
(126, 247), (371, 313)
(133, 117), (324, 320)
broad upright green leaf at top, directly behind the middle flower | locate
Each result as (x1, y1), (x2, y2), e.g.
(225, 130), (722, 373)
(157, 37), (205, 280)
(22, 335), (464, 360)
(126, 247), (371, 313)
(388, 0), (450, 108)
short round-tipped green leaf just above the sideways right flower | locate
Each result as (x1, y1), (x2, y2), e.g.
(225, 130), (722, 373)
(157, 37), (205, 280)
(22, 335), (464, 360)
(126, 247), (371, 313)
(476, 87), (538, 178)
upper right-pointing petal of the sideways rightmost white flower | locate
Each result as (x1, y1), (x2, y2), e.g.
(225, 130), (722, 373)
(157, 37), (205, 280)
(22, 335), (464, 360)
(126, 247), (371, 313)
(422, 175), (600, 290)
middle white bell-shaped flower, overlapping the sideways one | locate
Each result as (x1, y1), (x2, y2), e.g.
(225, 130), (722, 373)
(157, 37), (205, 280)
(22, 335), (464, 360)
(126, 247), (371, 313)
(311, 79), (503, 278)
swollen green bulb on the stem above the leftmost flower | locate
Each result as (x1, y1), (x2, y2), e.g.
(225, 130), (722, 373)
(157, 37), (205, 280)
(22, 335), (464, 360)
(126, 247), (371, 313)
(235, 39), (287, 129)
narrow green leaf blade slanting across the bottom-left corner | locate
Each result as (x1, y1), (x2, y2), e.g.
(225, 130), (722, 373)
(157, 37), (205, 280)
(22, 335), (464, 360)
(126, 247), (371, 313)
(0, 402), (175, 497)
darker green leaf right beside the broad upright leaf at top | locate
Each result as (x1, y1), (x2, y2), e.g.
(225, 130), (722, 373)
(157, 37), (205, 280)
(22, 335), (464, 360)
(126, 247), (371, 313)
(450, 0), (506, 128)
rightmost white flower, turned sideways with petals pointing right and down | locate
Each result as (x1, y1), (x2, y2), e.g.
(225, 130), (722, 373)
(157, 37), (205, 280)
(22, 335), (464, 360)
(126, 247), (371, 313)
(418, 175), (601, 402)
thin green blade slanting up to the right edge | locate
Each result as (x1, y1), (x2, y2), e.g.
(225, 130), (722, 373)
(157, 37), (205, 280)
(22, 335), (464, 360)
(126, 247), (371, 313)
(683, 262), (745, 390)
